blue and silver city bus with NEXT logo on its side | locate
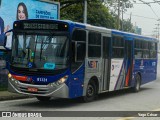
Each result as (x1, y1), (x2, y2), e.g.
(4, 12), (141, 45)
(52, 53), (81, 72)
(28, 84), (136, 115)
(4, 19), (158, 102)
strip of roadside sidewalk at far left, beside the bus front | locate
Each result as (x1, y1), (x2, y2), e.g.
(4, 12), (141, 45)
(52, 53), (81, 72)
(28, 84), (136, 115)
(0, 91), (31, 101)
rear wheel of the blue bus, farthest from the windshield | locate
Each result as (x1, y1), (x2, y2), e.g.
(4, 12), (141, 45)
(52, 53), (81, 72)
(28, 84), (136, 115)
(132, 74), (141, 92)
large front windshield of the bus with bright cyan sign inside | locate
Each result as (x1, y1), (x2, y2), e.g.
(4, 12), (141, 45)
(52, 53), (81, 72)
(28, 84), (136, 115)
(12, 34), (69, 70)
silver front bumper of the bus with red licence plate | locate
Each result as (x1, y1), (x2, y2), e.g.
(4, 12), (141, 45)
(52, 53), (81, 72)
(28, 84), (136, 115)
(8, 79), (69, 98)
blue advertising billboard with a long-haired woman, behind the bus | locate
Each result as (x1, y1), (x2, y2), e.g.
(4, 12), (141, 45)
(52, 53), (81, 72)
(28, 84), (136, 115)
(0, 0), (59, 49)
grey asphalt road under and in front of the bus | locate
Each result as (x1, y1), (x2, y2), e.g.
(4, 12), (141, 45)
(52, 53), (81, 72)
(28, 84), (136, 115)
(0, 55), (160, 120)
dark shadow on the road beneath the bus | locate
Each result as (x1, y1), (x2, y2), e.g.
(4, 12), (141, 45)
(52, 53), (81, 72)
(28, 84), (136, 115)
(12, 88), (152, 110)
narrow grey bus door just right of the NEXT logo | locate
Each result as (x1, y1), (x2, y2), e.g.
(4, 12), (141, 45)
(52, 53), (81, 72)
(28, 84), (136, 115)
(102, 36), (111, 91)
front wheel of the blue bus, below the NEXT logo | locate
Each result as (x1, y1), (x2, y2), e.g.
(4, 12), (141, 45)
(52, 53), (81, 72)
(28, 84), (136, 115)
(83, 81), (97, 102)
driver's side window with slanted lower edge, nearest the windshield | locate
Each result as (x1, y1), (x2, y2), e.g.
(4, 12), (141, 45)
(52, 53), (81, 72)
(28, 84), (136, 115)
(71, 30), (86, 72)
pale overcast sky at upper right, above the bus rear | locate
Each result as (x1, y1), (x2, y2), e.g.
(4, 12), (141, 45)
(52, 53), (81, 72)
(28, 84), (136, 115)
(124, 0), (160, 37)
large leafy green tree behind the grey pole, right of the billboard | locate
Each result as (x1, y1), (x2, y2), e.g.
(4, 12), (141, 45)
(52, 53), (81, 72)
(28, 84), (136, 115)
(54, 0), (115, 28)
